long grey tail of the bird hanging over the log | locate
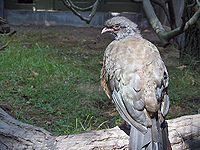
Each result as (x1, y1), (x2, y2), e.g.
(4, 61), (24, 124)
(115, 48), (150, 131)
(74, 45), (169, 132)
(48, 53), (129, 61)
(129, 118), (171, 150)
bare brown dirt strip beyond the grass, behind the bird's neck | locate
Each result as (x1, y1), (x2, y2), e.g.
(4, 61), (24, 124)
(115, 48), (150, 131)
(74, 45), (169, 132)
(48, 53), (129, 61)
(12, 25), (179, 63)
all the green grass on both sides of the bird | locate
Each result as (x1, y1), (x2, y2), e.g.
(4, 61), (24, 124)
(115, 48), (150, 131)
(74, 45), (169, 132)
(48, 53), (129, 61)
(0, 26), (200, 135)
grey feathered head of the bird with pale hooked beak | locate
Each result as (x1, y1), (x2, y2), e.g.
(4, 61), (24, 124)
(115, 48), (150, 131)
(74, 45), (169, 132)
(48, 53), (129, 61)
(101, 16), (141, 40)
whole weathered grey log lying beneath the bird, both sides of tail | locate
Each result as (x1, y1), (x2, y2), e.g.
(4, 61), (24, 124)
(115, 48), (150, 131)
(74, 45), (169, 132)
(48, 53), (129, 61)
(0, 108), (200, 150)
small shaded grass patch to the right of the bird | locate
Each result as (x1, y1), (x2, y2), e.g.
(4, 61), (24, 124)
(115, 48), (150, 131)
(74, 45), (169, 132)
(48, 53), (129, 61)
(168, 66), (200, 118)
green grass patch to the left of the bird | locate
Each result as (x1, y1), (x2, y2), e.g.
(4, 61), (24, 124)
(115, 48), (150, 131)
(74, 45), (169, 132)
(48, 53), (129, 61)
(0, 32), (119, 134)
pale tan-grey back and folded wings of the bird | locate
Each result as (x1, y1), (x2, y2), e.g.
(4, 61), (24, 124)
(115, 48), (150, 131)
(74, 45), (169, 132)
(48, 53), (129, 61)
(101, 39), (169, 133)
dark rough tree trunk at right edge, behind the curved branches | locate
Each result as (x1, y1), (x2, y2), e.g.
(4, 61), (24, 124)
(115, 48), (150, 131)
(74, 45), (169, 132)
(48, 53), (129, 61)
(180, 0), (200, 64)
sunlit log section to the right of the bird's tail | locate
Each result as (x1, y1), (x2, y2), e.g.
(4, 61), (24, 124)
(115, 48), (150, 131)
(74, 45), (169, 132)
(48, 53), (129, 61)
(167, 115), (200, 150)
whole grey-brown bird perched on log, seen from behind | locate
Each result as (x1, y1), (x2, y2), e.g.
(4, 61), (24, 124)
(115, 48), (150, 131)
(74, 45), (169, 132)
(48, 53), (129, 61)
(100, 16), (171, 150)
